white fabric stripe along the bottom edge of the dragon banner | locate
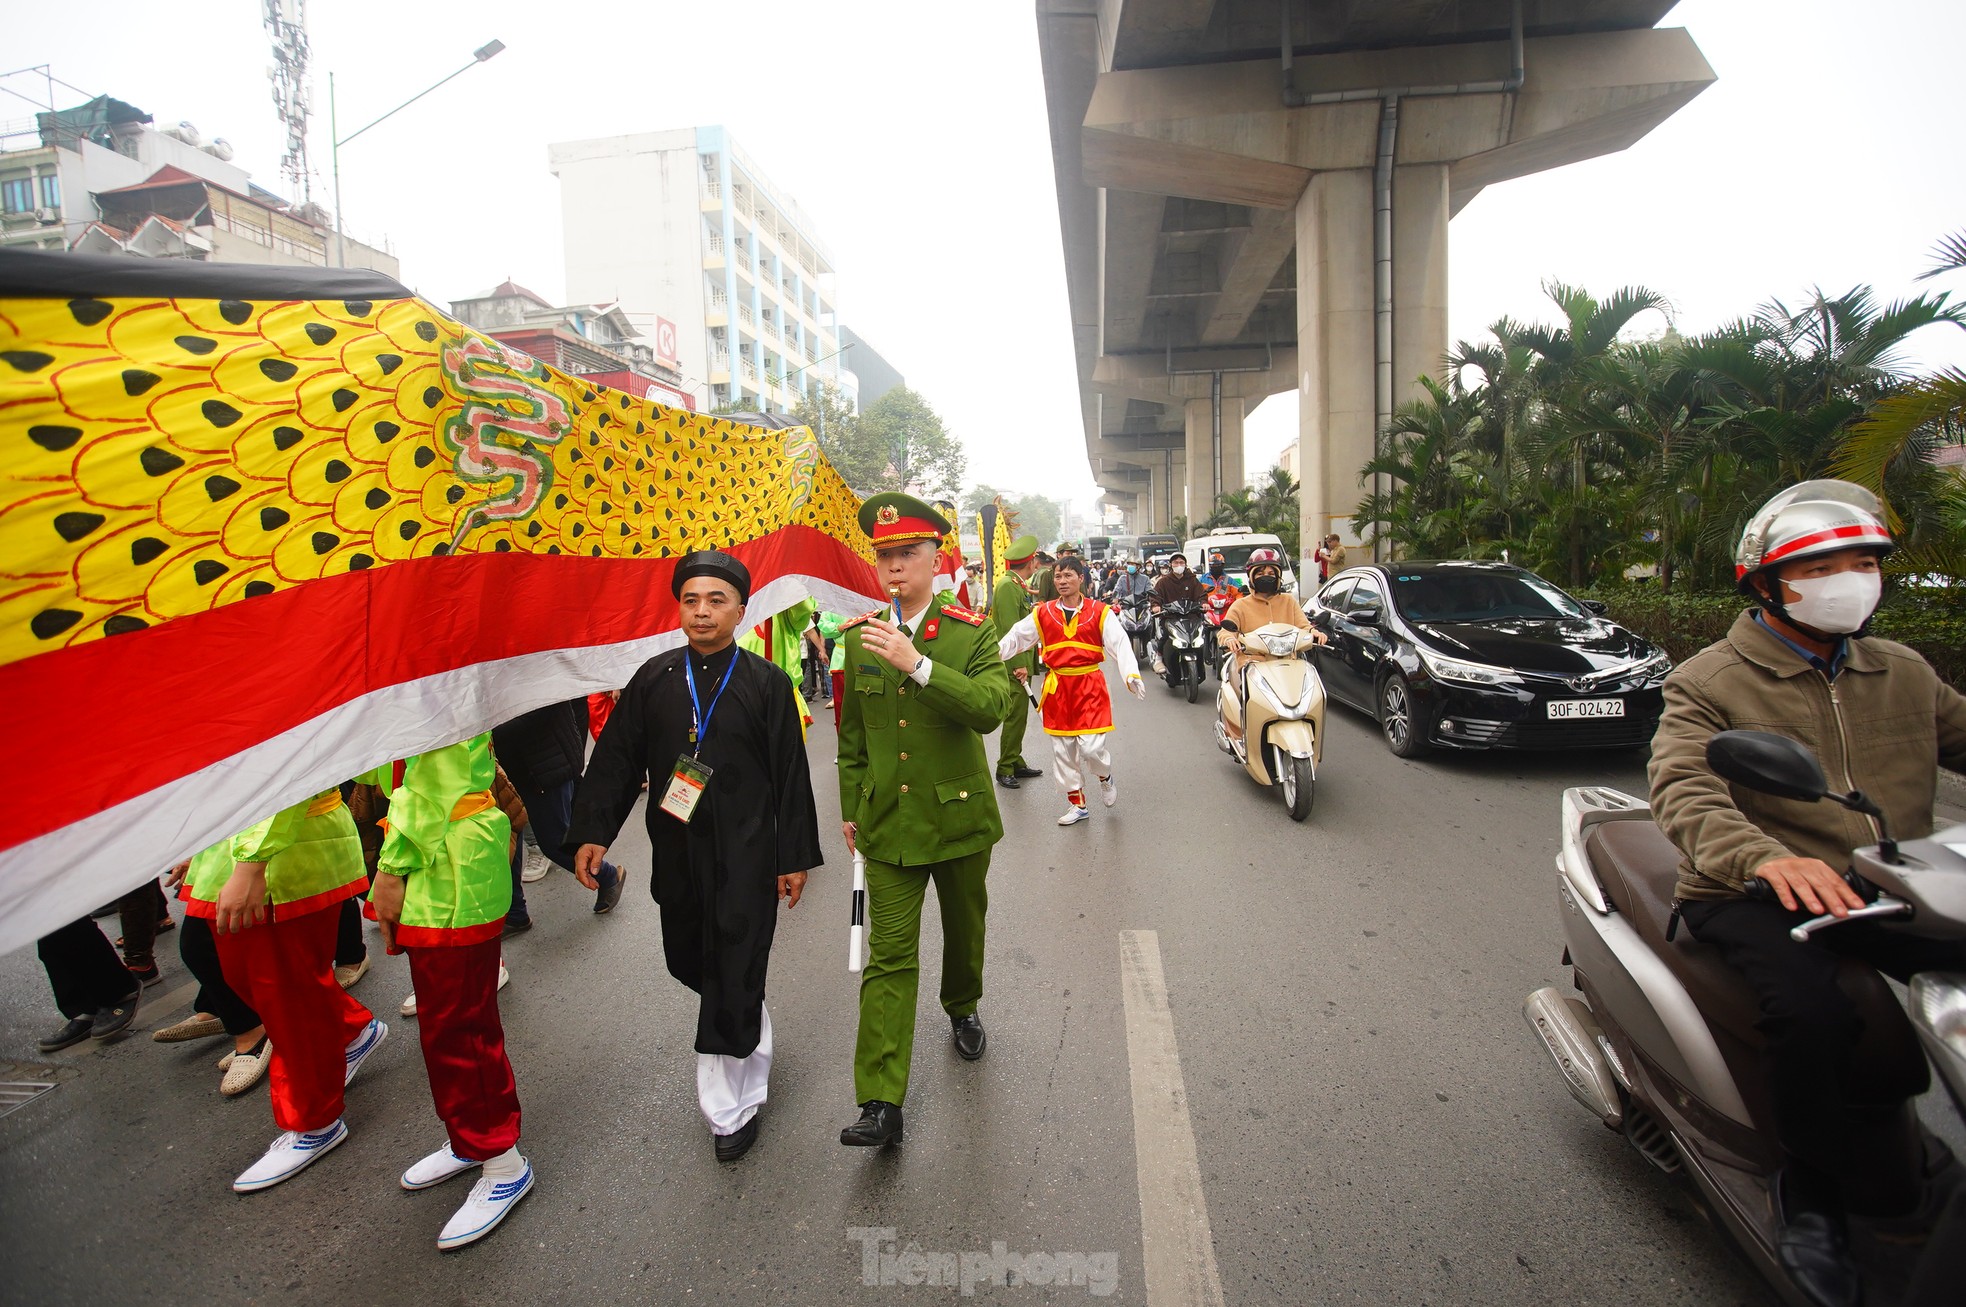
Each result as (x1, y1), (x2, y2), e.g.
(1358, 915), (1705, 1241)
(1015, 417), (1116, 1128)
(0, 574), (881, 953)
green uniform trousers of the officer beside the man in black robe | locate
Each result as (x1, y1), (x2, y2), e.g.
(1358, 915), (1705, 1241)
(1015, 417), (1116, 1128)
(853, 849), (989, 1103)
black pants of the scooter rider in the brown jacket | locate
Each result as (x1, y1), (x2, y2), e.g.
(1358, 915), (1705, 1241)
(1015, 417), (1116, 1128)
(1683, 898), (1966, 1215)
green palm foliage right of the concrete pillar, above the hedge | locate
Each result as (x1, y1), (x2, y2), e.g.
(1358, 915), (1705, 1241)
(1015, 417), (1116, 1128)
(1353, 275), (1966, 592)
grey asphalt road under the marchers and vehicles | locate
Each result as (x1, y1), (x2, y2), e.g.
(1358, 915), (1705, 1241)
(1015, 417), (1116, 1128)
(0, 668), (1960, 1307)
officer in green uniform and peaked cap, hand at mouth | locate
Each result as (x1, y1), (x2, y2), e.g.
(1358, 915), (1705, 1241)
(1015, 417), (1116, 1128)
(839, 493), (1012, 1148)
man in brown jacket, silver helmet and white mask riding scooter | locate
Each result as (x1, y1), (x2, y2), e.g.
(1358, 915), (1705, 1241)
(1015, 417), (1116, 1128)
(1649, 482), (1966, 1303)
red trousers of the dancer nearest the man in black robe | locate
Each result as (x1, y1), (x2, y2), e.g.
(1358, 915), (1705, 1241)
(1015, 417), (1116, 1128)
(405, 938), (519, 1162)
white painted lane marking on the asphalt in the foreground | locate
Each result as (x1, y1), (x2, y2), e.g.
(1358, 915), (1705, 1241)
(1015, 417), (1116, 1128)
(1119, 930), (1223, 1307)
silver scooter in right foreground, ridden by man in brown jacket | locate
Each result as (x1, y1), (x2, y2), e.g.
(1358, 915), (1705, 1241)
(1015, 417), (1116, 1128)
(1524, 731), (1966, 1307)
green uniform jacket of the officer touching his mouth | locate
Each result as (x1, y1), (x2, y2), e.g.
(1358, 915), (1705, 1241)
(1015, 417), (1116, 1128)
(839, 592), (1011, 867)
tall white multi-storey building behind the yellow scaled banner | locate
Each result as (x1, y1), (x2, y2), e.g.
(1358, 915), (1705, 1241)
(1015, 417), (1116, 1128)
(549, 126), (853, 413)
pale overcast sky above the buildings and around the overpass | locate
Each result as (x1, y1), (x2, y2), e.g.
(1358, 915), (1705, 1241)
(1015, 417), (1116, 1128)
(0, 0), (1966, 514)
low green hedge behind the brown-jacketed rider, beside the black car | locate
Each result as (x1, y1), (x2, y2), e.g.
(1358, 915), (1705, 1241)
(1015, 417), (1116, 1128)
(1575, 582), (1966, 688)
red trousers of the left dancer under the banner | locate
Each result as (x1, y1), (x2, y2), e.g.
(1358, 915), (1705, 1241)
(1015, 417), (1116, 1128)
(212, 904), (372, 1130)
